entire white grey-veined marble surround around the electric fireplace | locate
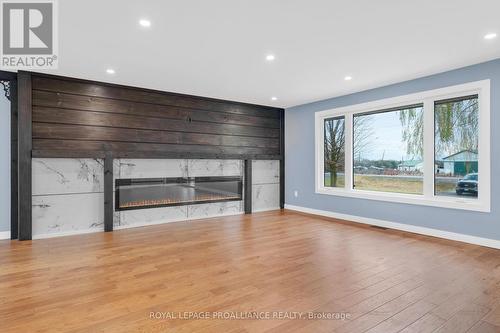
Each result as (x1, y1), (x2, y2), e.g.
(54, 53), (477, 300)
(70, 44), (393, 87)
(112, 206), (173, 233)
(32, 158), (280, 238)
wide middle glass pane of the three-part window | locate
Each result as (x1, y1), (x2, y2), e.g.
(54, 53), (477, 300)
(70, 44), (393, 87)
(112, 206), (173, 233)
(353, 104), (424, 194)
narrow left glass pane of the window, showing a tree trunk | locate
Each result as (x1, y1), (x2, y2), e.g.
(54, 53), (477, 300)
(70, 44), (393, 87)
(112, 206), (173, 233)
(324, 117), (345, 187)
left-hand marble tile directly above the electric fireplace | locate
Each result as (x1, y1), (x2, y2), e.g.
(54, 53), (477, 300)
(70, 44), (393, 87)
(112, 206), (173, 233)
(115, 159), (187, 178)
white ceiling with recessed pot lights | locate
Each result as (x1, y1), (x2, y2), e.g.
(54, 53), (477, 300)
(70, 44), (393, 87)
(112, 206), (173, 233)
(41, 0), (500, 107)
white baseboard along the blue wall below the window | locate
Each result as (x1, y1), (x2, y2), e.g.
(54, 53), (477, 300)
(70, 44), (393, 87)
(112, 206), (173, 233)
(285, 204), (500, 249)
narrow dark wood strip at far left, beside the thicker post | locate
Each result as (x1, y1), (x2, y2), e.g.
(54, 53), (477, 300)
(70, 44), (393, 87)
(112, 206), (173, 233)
(10, 79), (19, 239)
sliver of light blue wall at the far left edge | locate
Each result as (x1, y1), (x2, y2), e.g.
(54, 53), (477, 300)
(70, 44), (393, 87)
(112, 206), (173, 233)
(0, 90), (10, 232)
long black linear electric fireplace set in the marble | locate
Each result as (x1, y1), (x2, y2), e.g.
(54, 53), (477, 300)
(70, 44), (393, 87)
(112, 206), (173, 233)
(115, 177), (243, 211)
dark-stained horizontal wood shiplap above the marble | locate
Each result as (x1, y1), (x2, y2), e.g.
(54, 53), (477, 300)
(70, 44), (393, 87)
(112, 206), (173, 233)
(31, 73), (283, 159)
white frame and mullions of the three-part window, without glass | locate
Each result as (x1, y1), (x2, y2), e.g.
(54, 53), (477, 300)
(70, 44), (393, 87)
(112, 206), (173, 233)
(315, 80), (491, 212)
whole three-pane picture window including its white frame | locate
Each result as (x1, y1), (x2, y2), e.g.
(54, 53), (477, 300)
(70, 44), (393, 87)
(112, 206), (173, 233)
(315, 80), (490, 211)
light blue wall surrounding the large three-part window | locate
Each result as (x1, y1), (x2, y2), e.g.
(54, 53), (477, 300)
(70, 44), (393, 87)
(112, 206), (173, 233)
(285, 59), (500, 240)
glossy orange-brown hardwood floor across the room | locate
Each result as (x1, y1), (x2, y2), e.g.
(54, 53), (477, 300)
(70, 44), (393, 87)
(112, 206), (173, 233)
(0, 211), (500, 333)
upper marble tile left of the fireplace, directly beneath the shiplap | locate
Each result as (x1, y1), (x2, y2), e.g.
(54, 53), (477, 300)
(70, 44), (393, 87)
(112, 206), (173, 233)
(32, 158), (104, 195)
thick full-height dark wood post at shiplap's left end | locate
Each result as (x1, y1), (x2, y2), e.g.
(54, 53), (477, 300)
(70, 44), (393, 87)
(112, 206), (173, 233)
(17, 71), (32, 240)
